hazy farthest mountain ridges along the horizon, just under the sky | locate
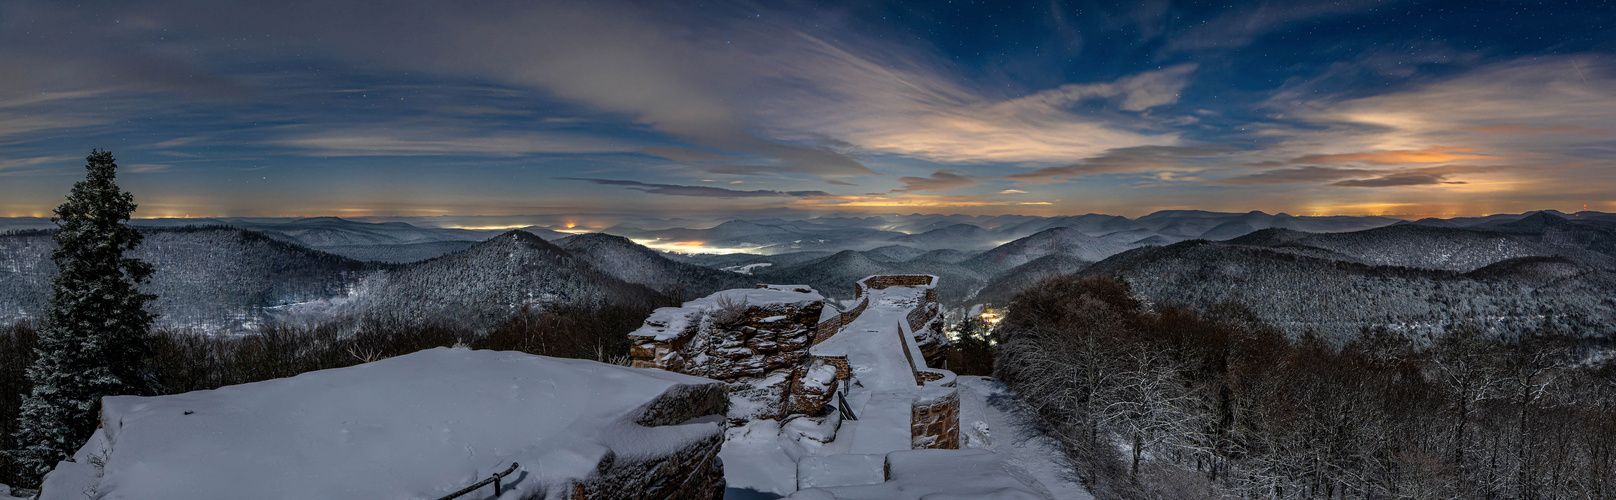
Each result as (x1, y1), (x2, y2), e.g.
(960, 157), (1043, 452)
(0, 210), (1616, 264)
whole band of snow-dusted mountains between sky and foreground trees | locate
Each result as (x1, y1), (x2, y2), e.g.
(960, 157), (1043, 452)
(0, 210), (1616, 336)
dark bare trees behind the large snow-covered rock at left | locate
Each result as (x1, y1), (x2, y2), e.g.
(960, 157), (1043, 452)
(0, 299), (653, 485)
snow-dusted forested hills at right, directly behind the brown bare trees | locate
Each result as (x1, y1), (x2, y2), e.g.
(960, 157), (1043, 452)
(1084, 239), (1616, 340)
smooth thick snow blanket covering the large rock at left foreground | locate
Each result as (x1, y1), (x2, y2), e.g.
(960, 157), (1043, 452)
(42, 348), (727, 500)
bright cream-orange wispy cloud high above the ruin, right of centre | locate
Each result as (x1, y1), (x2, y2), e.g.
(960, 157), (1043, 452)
(764, 61), (1196, 165)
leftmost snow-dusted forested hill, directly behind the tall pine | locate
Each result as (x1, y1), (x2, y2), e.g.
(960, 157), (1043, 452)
(0, 227), (370, 330)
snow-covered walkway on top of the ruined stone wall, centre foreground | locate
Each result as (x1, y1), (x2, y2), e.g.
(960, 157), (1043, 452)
(719, 281), (1092, 500)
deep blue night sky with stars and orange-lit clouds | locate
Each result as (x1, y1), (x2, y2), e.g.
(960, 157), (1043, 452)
(0, 0), (1616, 217)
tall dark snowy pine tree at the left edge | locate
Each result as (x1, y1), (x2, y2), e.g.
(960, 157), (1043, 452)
(8, 150), (154, 477)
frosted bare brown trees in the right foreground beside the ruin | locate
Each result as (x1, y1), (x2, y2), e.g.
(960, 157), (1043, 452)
(995, 277), (1616, 498)
